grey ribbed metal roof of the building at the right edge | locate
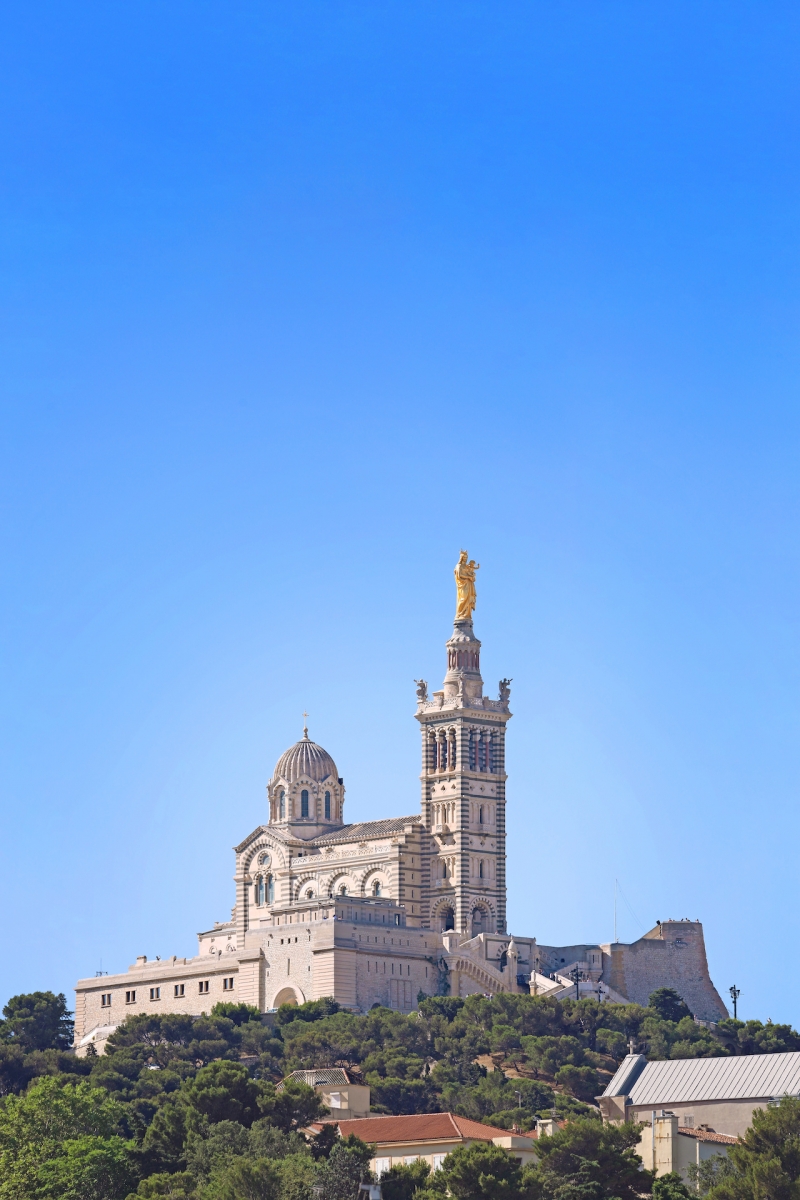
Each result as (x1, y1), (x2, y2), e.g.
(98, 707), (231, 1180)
(603, 1050), (800, 1108)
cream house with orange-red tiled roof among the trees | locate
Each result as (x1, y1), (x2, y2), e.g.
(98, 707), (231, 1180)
(318, 1112), (536, 1175)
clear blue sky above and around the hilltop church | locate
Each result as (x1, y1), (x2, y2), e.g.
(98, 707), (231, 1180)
(0, 0), (800, 1024)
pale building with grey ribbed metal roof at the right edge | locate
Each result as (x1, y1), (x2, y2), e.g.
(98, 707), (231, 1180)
(599, 1050), (800, 1137)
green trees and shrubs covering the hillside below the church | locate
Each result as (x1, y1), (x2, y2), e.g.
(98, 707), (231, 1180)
(0, 989), (800, 1200)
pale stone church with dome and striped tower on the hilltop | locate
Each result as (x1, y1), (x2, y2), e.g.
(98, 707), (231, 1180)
(76, 552), (727, 1052)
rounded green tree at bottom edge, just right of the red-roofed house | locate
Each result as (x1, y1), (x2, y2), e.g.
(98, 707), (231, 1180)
(525, 1117), (652, 1200)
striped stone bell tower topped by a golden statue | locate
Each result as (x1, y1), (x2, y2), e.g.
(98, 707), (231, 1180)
(416, 551), (511, 936)
